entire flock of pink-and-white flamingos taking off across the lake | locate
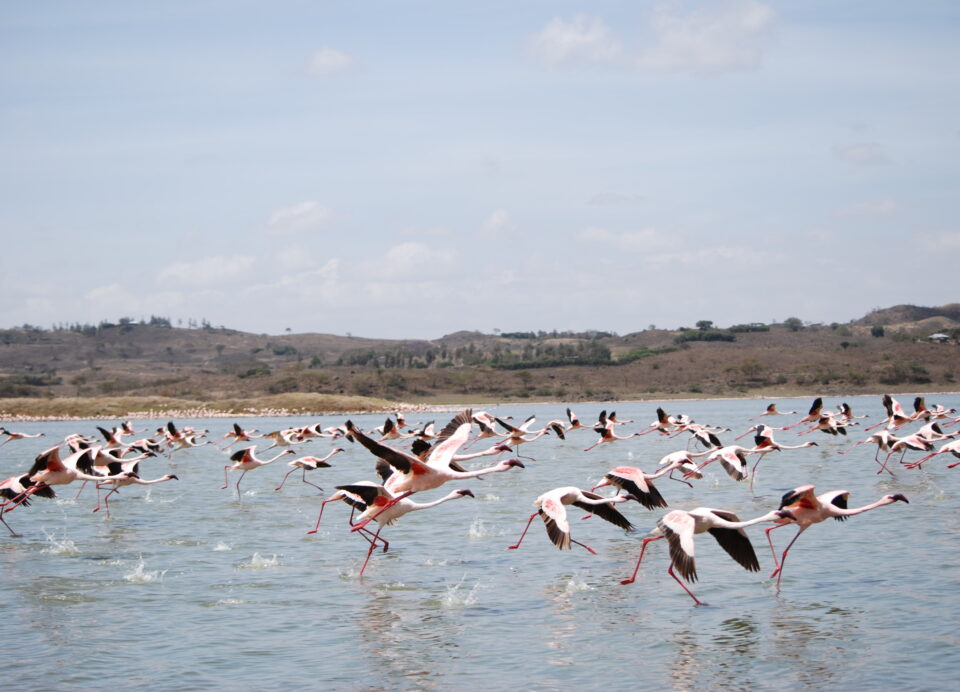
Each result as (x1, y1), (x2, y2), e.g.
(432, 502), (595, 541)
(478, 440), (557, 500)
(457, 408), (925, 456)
(0, 395), (960, 604)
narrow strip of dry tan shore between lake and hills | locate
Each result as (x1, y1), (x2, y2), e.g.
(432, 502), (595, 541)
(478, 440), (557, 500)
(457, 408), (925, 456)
(0, 389), (960, 423)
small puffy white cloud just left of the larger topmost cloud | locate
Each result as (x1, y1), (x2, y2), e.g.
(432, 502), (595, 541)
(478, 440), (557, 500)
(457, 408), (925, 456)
(529, 14), (623, 67)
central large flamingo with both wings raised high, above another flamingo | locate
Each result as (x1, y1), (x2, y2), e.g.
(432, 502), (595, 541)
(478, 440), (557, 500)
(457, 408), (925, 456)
(346, 409), (524, 531)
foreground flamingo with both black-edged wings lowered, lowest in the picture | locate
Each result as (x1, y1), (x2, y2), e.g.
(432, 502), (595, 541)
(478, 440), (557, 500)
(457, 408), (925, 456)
(620, 507), (789, 605)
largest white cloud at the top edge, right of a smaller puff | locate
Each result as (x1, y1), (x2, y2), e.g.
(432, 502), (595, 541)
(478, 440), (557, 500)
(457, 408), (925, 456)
(636, 0), (774, 74)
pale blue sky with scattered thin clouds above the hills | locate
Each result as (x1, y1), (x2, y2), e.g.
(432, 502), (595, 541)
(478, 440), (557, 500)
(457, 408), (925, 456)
(0, 0), (960, 339)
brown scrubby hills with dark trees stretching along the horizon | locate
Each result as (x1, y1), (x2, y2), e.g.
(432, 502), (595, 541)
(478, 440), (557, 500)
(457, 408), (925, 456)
(0, 304), (960, 411)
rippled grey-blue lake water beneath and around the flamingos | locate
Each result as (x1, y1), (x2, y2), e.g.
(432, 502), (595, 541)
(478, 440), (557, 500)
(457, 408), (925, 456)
(0, 395), (960, 690)
